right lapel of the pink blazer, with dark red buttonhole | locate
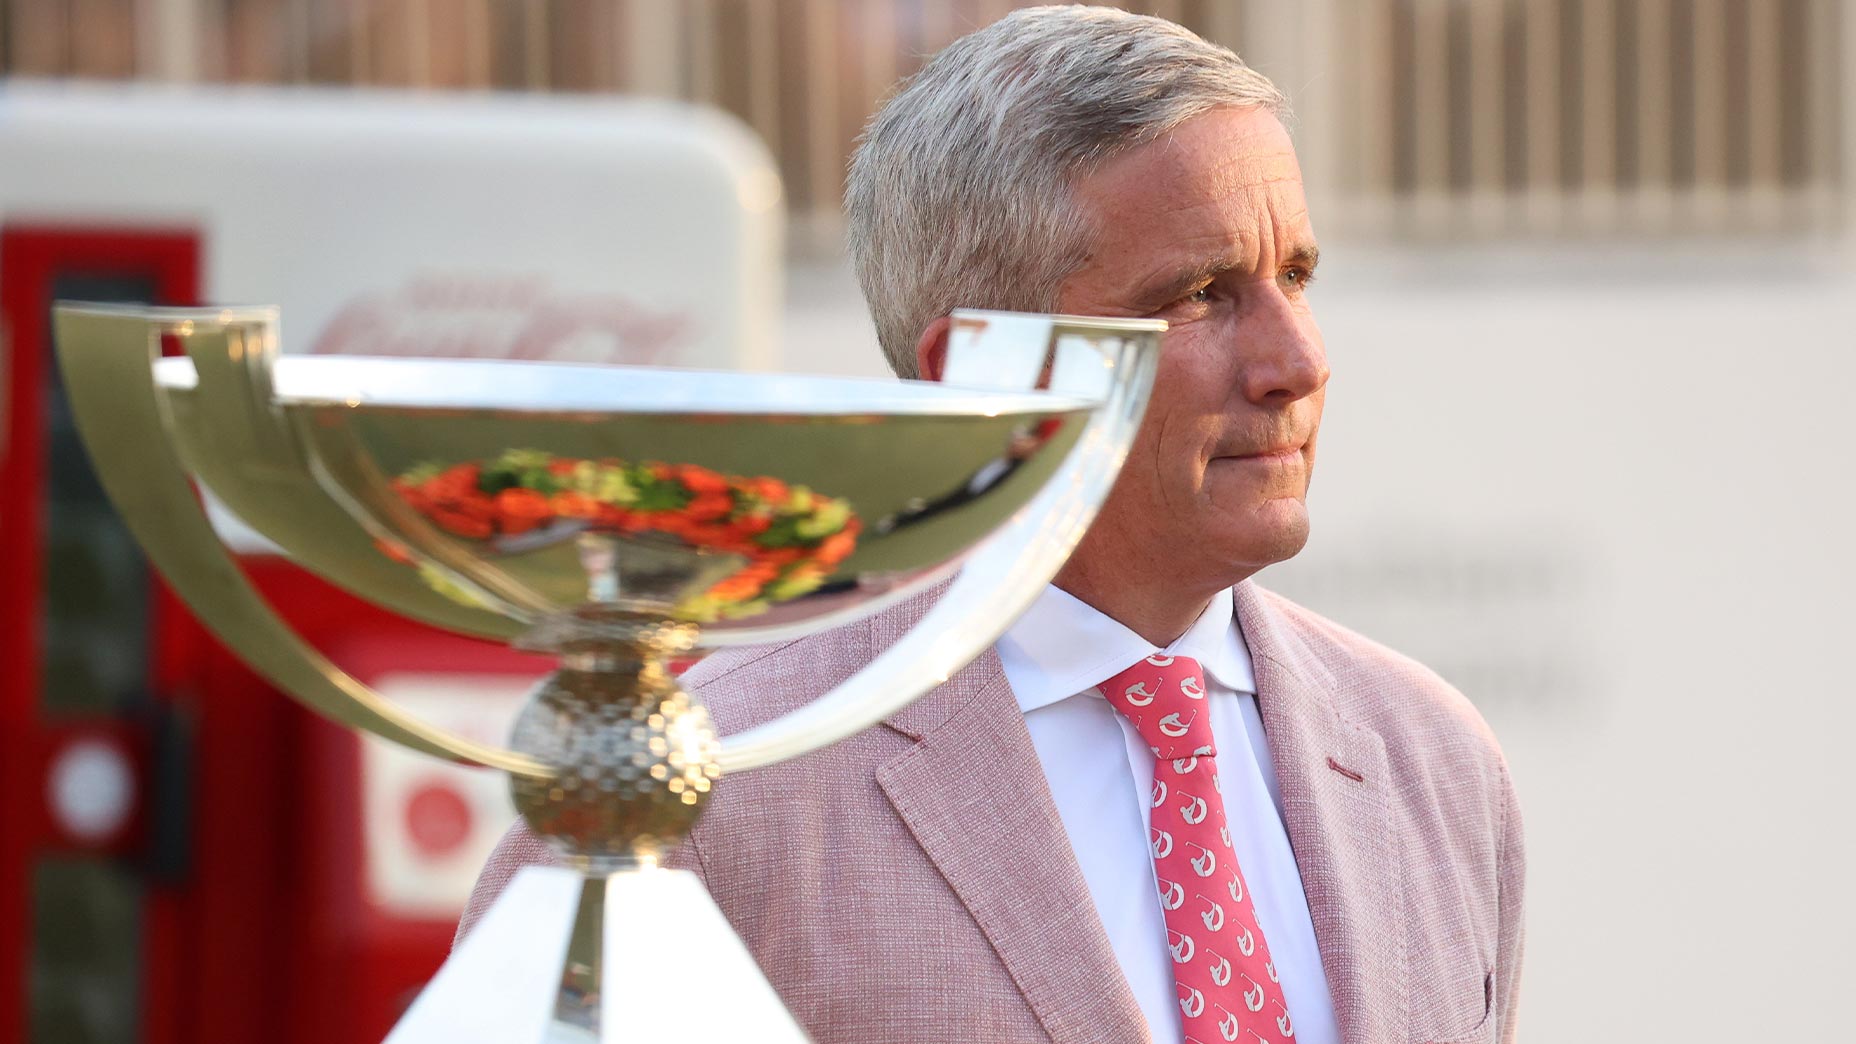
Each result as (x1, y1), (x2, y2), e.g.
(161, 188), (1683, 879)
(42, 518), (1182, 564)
(1234, 581), (1409, 1042)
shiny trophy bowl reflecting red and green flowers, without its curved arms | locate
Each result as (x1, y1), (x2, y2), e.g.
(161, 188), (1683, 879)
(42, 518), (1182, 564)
(156, 357), (1095, 648)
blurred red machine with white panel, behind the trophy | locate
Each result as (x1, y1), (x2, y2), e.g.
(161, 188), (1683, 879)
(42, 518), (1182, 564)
(0, 223), (548, 1044)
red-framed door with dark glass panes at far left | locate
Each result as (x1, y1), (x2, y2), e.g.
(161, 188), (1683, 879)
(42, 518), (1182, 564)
(0, 223), (200, 1042)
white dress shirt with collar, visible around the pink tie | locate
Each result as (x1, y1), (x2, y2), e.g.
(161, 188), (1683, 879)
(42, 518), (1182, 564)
(997, 587), (1340, 1044)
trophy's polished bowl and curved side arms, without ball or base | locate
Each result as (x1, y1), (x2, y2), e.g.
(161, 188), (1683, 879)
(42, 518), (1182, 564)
(58, 299), (1164, 776)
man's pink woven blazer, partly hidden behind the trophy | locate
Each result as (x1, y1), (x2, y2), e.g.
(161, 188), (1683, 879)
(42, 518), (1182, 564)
(458, 581), (1524, 1044)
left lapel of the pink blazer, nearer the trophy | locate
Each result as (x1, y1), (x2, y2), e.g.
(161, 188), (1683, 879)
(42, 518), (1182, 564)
(876, 609), (1149, 1044)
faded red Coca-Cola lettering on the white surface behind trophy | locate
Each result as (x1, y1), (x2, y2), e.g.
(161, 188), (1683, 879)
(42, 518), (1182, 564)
(310, 275), (694, 366)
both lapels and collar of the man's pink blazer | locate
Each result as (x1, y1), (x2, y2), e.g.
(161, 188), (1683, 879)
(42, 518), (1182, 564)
(869, 581), (1409, 1042)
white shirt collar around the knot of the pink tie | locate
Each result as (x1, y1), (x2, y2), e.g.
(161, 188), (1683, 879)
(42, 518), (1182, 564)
(997, 585), (1257, 713)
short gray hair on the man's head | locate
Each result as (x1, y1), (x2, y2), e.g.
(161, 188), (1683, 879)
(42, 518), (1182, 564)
(844, 6), (1288, 377)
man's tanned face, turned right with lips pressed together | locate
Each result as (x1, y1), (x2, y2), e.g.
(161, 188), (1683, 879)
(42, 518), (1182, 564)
(1058, 108), (1327, 594)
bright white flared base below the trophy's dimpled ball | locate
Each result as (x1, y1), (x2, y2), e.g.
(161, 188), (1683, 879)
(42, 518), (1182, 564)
(386, 866), (807, 1044)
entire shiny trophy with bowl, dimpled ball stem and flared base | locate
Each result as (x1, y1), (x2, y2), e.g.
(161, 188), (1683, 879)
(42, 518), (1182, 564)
(56, 305), (1166, 1040)
